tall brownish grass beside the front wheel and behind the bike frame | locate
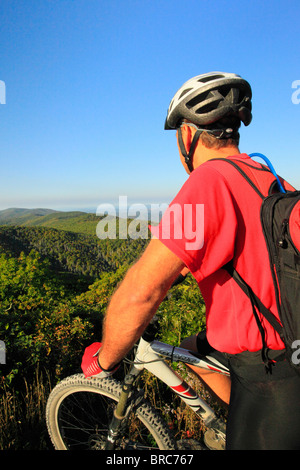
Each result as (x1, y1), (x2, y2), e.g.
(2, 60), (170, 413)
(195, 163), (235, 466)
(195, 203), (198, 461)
(0, 365), (227, 451)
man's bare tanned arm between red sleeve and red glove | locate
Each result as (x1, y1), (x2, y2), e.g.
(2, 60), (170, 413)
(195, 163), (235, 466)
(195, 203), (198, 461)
(99, 239), (184, 369)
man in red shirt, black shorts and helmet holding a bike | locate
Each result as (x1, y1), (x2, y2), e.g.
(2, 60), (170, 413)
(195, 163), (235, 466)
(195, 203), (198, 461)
(83, 72), (300, 449)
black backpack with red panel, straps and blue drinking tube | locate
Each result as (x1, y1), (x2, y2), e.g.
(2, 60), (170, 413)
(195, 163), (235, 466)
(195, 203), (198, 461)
(217, 154), (300, 373)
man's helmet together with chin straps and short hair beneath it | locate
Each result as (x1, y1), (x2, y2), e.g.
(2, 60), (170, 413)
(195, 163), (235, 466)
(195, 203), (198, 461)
(165, 72), (252, 171)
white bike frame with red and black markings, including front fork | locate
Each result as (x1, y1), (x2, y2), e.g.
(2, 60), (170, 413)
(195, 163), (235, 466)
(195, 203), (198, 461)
(106, 326), (229, 450)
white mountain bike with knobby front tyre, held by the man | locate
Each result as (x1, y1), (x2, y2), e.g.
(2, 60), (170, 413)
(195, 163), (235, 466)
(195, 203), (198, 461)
(46, 318), (229, 451)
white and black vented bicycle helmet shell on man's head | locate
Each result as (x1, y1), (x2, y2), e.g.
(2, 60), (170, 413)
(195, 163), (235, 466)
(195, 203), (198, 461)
(165, 72), (252, 129)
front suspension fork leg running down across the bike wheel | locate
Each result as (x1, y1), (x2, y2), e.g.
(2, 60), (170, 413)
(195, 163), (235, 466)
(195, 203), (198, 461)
(105, 366), (142, 450)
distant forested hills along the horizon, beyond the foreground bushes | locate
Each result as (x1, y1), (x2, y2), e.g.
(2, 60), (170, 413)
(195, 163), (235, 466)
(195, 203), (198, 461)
(0, 209), (147, 279)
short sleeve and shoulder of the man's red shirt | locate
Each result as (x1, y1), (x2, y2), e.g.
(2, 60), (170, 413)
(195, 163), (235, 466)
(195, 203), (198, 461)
(150, 164), (237, 282)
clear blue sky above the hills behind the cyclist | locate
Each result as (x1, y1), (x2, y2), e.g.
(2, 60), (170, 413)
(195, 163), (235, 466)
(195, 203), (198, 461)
(0, 0), (300, 210)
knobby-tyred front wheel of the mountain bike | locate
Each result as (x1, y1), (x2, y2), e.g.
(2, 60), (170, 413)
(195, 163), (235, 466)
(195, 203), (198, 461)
(46, 374), (176, 450)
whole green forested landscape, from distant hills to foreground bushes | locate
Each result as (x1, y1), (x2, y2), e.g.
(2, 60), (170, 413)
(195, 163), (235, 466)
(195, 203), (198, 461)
(0, 209), (205, 450)
